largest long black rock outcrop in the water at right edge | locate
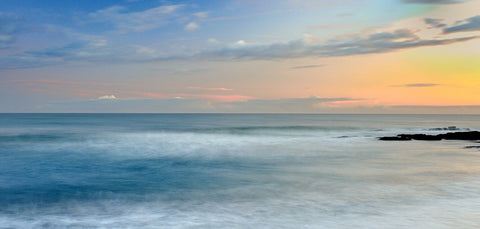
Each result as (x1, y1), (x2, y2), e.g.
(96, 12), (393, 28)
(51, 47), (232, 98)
(378, 131), (480, 141)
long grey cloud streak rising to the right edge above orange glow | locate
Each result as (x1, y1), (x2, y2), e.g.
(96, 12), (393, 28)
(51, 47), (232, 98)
(193, 29), (478, 60)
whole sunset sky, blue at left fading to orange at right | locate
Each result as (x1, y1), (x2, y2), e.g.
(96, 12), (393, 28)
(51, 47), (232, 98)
(0, 0), (480, 114)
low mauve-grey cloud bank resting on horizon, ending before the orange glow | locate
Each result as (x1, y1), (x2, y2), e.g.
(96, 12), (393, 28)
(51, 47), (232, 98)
(32, 95), (361, 113)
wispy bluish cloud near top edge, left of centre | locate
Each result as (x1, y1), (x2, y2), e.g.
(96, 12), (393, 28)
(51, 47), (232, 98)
(89, 5), (183, 32)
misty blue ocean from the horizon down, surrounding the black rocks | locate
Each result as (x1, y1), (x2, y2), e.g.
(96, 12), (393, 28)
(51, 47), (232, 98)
(0, 114), (480, 228)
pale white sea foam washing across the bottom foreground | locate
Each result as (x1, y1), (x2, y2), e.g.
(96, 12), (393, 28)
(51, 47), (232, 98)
(0, 175), (480, 228)
